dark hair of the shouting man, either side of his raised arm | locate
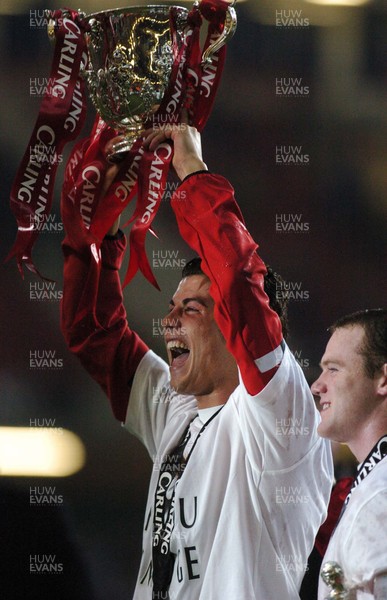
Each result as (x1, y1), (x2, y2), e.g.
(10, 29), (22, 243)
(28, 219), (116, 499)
(181, 257), (289, 339)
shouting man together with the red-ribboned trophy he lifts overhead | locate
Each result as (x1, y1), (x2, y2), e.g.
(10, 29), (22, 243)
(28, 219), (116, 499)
(5, 0), (332, 600)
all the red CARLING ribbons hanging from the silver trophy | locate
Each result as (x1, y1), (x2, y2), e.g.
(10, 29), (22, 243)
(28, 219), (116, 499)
(8, 0), (235, 288)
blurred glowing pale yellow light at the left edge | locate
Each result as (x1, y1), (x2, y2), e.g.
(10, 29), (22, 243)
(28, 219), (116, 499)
(0, 427), (86, 477)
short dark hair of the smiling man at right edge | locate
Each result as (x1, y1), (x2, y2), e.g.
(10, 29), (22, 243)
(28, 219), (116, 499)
(328, 308), (387, 379)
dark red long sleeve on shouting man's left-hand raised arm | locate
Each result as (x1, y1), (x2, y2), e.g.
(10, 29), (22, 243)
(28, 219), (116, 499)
(61, 231), (148, 421)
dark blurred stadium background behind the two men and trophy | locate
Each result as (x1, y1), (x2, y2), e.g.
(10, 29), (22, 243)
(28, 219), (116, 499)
(0, 0), (387, 600)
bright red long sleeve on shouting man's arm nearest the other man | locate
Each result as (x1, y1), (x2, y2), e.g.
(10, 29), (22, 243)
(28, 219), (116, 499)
(172, 173), (282, 395)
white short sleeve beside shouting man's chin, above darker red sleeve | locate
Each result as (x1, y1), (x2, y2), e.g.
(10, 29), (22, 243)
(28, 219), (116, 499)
(125, 350), (196, 458)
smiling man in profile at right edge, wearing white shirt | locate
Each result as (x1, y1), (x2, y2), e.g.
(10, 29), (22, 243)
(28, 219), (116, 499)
(312, 309), (387, 600)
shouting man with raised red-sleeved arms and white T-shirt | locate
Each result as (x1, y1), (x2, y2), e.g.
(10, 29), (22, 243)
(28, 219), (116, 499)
(62, 125), (332, 600)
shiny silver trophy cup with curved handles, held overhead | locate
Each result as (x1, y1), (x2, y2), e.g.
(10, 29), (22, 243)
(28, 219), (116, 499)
(49, 2), (237, 162)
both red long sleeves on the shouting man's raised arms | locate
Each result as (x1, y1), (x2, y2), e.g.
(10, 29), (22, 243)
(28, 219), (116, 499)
(61, 174), (282, 421)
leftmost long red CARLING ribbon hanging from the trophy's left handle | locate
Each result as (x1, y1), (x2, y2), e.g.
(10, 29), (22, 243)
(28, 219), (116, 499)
(6, 10), (87, 276)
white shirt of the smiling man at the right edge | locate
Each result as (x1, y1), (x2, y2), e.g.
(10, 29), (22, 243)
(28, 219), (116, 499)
(318, 457), (387, 600)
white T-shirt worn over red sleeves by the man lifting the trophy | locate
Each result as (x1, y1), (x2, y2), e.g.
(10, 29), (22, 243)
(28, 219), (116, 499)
(126, 348), (333, 600)
